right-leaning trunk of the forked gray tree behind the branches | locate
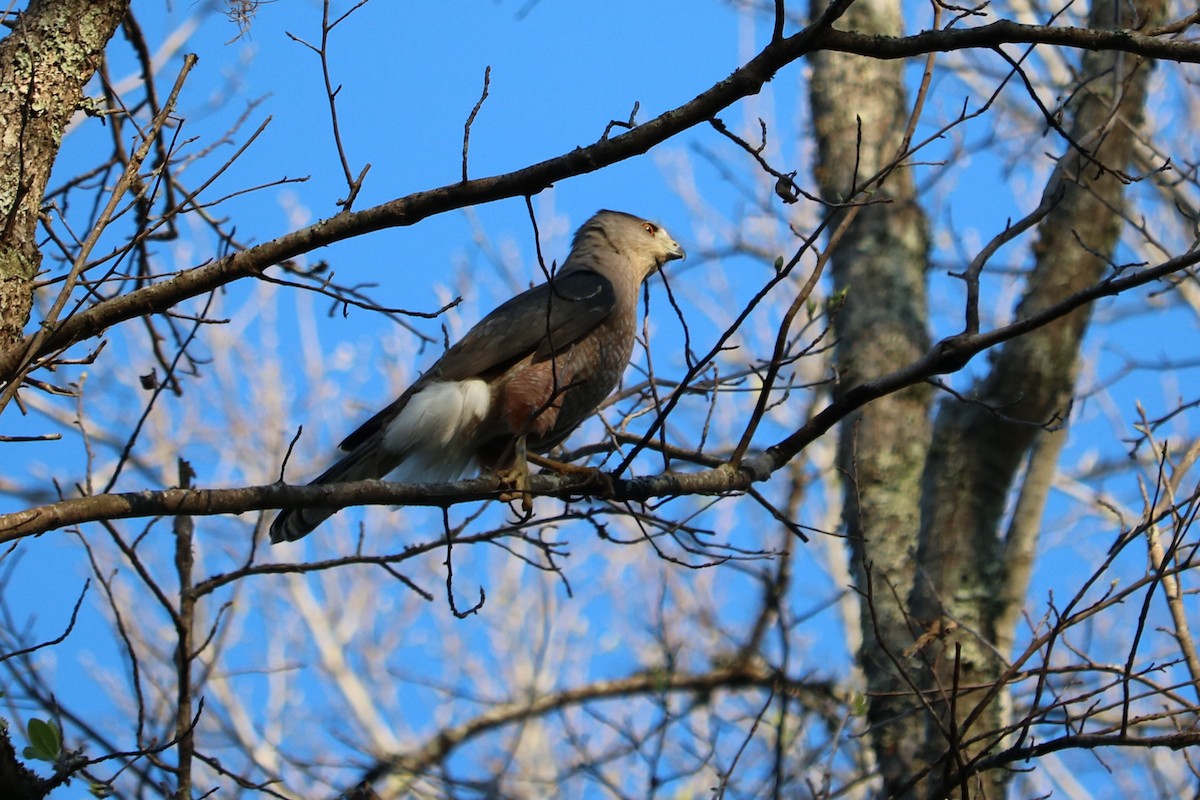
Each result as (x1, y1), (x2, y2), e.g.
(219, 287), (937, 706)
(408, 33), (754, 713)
(911, 0), (1165, 796)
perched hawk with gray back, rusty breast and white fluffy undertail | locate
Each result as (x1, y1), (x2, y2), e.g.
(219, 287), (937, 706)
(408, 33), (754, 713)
(271, 211), (684, 542)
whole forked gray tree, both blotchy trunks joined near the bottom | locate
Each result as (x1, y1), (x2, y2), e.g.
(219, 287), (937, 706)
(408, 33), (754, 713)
(811, 0), (1162, 798)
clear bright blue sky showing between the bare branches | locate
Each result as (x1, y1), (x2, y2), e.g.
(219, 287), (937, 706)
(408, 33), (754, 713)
(0, 0), (1195, 798)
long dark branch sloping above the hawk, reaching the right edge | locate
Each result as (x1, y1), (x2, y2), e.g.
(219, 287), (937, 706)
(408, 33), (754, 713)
(7, 11), (1200, 380)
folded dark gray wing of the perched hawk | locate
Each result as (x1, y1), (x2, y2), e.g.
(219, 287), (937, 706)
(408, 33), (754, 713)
(341, 270), (617, 450)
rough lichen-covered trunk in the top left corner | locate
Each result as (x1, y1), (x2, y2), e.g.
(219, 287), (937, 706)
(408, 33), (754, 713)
(0, 0), (128, 350)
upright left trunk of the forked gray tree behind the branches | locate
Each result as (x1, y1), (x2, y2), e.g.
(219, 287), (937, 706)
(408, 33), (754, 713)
(811, 0), (930, 786)
